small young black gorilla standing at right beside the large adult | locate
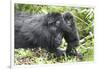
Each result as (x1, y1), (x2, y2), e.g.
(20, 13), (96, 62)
(63, 12), (82, 59)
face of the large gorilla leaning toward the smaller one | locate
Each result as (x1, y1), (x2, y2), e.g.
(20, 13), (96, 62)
(47, 13), (63, 33)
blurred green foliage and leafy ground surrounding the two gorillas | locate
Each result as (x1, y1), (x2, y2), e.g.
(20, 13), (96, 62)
(14, 4), (94, 65)
